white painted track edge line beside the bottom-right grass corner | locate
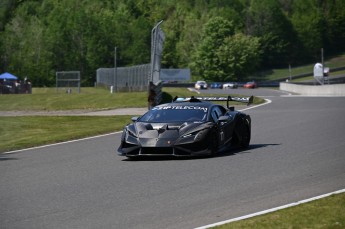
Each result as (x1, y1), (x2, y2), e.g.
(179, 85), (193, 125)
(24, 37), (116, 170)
(195, 189), (345, 229)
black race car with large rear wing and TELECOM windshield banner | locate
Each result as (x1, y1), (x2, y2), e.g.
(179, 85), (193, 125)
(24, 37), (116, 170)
(118, 96), (253, 158)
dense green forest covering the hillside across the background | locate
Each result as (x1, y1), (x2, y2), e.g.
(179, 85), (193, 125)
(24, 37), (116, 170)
(0, 0), (345, 86)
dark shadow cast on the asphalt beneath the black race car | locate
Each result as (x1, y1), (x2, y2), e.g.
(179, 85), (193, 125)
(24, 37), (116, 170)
(122, 144), (280, 162)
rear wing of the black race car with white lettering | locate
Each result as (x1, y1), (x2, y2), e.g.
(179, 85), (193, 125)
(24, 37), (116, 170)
(173, 95), (254, 109)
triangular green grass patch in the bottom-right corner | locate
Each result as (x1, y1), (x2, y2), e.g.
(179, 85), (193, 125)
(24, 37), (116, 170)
(214, 193), (345, 229)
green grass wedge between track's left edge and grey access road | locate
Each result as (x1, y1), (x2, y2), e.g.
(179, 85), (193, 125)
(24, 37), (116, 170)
(0, 115), (131, 153)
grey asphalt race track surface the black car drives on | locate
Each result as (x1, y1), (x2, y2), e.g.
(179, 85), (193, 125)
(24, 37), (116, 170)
(0, 89), (345, 229)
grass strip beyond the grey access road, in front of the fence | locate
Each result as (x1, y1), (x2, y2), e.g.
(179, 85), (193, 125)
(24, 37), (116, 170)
(0, 88), (258, 111)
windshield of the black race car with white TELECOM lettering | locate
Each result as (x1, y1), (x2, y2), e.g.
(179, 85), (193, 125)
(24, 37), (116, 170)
(139, 105), (208, 123)
